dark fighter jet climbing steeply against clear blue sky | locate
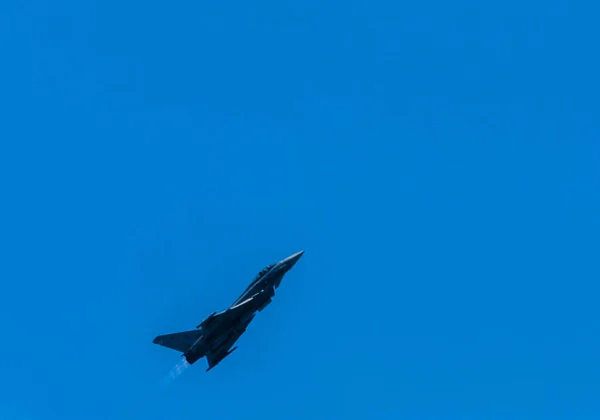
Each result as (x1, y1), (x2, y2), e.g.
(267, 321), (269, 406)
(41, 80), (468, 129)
(153, 251), (304, 372)
